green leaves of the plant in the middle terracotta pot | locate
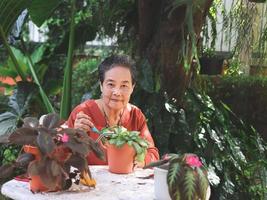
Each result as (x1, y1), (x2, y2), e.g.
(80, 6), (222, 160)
(101, 126), (148, 162)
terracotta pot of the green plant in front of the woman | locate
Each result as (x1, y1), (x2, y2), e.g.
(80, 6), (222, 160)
(107, 144), (136, 174)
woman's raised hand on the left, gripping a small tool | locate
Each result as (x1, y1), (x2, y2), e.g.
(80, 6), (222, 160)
(74, 111), (94, 132)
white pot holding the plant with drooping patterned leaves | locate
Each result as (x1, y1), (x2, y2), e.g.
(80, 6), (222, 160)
(154, 167), (171, 200)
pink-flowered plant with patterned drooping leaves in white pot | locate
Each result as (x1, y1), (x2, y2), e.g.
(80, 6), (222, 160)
(144, 153), (210, 200)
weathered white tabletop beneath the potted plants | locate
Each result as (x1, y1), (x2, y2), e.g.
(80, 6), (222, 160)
(1, 166), (155, 200)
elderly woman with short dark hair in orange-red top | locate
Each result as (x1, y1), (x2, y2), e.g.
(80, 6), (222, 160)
(68, 55), (159, 167)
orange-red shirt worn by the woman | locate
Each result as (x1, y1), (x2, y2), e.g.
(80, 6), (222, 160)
(67, 100), (159, 165)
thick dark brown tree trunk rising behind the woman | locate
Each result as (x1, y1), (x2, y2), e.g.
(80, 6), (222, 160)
(138, 0), (212, 104)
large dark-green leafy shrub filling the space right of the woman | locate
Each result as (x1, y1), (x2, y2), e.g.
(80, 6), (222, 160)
(136, 90), (267, 200)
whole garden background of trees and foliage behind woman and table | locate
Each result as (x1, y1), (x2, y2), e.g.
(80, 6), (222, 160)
(0, 0), (267, 200)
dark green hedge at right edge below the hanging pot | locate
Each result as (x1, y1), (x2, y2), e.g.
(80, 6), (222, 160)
(195, 76), (267, 141)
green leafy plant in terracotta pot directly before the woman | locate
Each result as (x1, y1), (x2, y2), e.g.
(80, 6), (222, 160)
(101, 126), (148, 174)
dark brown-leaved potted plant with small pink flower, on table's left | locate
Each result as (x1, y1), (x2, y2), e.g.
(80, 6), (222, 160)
(0, 113), (104, 192)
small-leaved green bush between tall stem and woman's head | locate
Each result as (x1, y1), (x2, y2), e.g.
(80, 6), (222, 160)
(72, 59), (100, 107)
